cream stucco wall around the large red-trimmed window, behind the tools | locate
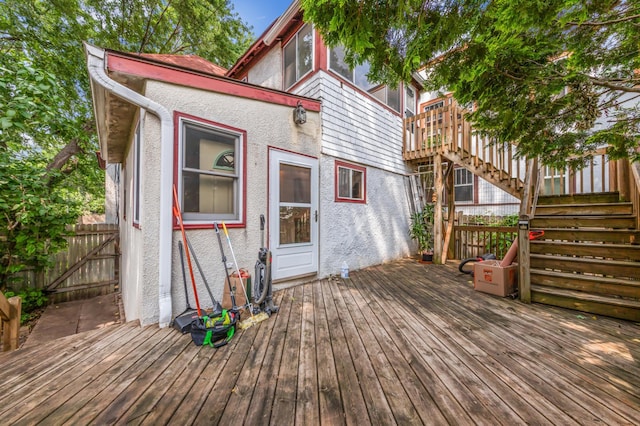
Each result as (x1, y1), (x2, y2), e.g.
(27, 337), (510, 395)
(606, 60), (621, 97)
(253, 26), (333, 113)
(130, 81), (320, 325)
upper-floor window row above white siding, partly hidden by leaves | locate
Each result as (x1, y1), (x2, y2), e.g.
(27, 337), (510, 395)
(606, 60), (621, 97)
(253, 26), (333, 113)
(329, 46), (400, 112)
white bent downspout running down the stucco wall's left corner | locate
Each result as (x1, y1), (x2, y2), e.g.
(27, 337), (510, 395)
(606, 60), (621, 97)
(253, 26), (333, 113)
(84, 43), (173, 328)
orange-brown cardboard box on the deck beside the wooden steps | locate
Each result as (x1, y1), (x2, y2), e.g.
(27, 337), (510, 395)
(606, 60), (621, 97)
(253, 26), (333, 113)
(473, 260), (518, 297)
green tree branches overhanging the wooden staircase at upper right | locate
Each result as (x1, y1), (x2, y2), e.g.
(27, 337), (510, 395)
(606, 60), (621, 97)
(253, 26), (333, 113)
(301, 0), (640, 167)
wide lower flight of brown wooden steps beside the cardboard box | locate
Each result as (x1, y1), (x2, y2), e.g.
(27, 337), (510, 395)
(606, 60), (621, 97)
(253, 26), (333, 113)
(530, 192), (640, 321)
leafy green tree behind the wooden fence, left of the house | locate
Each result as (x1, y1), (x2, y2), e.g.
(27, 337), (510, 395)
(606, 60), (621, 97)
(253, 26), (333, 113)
(0, 0), (250, 287)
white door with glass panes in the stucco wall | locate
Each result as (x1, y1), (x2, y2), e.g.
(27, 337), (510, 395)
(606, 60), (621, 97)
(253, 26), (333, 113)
(269, 149), (318, 280)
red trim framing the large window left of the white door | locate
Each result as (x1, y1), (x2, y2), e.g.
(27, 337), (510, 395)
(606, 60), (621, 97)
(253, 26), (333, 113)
(172, 111), (247, 230)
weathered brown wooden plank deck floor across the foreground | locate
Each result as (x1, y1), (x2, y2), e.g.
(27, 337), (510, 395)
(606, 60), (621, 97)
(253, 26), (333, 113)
(0, 260), (640, 425)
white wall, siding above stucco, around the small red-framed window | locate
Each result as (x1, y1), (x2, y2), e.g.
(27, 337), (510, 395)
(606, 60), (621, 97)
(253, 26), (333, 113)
(296, 71), (414, 277)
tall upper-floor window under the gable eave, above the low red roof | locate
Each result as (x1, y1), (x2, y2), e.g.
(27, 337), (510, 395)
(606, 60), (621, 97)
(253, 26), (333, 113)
(284, 25), (313, 89)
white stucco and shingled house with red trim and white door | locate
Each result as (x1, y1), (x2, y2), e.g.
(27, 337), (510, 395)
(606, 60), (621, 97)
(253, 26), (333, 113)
(86, 2), (417, 326)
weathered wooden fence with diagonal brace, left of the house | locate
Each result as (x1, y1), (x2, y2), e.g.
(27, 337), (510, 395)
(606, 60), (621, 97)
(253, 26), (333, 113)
(11, 224), (120, 303)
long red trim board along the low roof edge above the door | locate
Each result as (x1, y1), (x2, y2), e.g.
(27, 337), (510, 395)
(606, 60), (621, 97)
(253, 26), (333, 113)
(107, 52), (320, 112)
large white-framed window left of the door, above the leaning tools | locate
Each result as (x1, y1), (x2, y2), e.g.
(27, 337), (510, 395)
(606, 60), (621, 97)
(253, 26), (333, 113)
(178, 118), (245, 225)
